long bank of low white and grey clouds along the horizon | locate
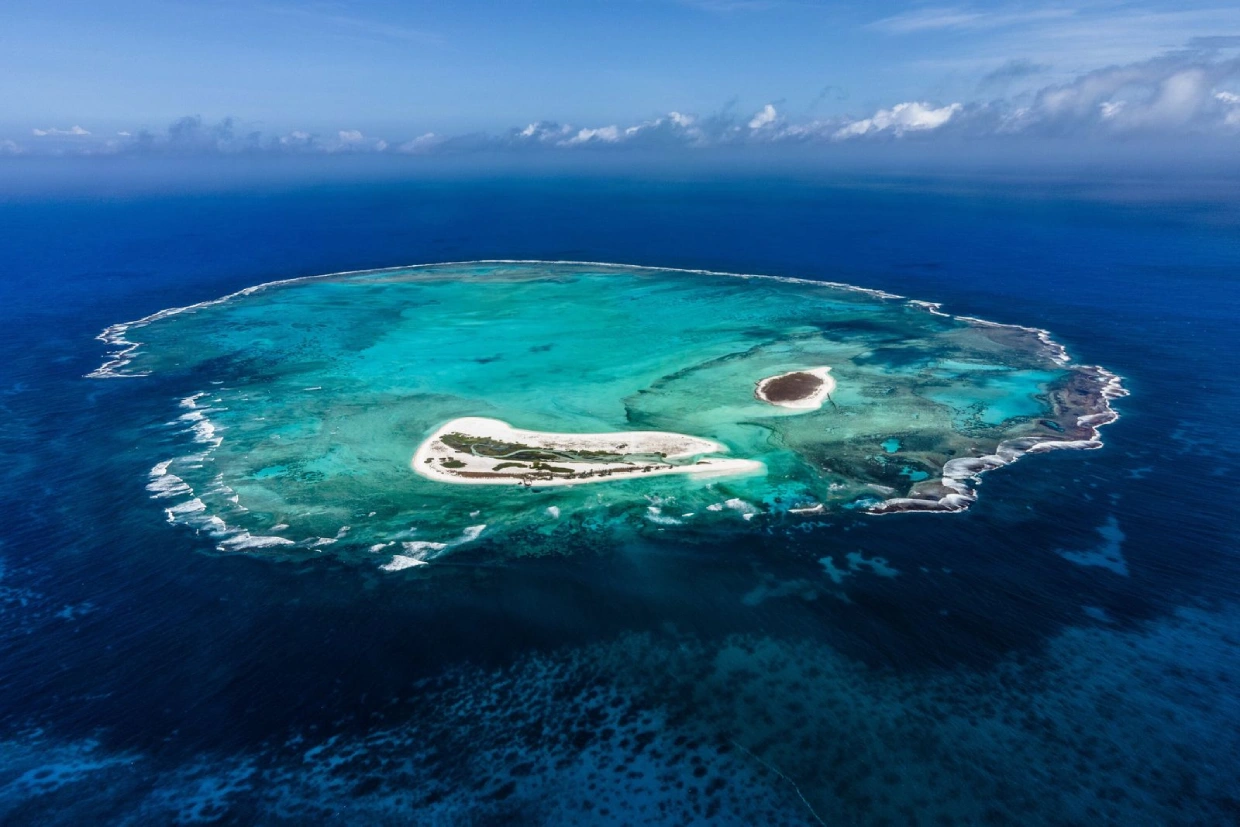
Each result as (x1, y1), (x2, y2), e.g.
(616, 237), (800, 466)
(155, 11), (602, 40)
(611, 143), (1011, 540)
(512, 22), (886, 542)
(7, 50), (1240, 161)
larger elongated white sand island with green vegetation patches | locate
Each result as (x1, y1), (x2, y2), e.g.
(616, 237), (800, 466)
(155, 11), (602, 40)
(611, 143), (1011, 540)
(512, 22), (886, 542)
(412, 417), (766, 486)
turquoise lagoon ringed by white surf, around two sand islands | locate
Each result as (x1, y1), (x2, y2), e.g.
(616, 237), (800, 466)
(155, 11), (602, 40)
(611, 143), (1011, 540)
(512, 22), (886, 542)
(92, 262), (1122, 570)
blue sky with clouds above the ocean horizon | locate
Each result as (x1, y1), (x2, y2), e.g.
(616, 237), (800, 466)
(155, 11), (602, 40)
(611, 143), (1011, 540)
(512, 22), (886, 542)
(0, 0), (1240, 155)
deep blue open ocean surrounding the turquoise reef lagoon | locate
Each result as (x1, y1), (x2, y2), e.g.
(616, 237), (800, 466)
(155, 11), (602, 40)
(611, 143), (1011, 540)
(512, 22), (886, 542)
(0, 161), (1240, 825)
